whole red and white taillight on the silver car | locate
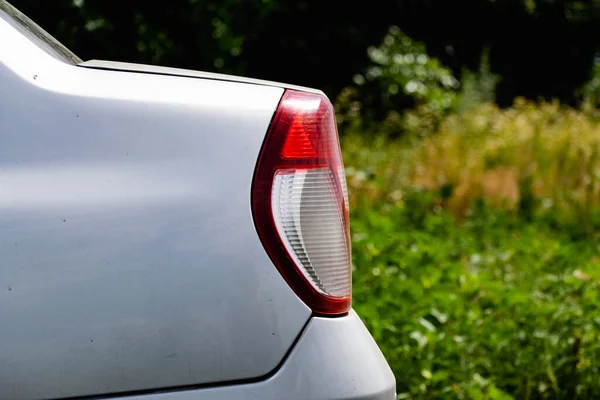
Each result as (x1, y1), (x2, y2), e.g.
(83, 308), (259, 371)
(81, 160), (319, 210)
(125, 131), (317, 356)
(252, 90), (352, 315)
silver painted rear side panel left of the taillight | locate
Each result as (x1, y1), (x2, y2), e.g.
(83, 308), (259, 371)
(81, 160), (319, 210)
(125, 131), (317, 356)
(0, 9), (310, 399)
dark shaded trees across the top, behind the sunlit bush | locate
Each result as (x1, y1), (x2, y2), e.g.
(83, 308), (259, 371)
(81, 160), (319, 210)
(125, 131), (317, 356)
(11, 0), (600, 104)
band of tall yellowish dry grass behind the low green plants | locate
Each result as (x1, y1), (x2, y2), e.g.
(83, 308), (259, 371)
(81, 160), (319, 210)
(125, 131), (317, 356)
(342, 99), (600, 225)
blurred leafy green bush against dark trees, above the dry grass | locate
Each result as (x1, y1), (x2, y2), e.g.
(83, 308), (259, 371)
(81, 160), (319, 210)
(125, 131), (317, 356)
(336, 26), (500, 137)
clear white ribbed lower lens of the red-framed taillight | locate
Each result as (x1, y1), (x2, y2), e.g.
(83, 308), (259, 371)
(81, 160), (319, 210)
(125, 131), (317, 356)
(271, 168), (351, 297)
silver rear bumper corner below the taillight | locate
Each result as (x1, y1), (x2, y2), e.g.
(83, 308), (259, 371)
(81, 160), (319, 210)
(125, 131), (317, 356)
(115, 311), (396, 400)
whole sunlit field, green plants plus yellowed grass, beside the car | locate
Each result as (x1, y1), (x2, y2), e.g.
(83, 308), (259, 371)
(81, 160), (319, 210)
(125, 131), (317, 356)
(342, 102), (600, 399)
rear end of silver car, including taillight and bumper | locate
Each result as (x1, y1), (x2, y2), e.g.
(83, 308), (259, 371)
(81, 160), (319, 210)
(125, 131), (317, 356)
(0, 0), (395, 400)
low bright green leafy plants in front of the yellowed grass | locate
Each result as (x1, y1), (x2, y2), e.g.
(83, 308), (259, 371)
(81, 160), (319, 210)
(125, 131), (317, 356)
(352, 192), (600, 399)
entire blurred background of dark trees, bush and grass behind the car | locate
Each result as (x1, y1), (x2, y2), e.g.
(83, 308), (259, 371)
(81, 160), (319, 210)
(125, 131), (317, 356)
(12, 0), (600, 399)
